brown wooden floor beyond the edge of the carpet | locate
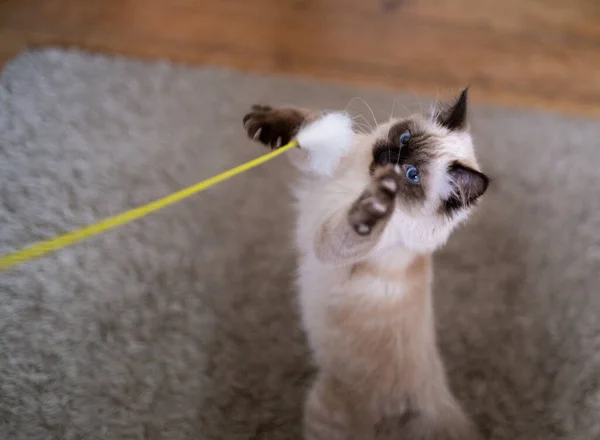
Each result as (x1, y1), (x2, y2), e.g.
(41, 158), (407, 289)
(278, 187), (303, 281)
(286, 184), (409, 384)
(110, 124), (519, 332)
(0, 0), (600, 116)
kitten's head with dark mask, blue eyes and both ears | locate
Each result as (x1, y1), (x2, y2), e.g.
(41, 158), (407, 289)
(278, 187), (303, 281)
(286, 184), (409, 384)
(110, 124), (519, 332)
(338, 89), (489, 252)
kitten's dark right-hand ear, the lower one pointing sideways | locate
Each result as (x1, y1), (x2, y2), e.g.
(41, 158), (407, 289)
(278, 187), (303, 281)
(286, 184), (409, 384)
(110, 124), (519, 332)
(445, 162), (490, 211)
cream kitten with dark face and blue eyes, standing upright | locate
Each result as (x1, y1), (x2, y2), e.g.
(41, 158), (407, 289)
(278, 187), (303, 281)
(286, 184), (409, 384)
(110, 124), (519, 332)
(243, 89), (489, 440)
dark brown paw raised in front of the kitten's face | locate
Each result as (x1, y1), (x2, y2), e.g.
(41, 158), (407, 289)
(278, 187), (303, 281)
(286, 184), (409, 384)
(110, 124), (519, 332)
(348, 166), (400, 235)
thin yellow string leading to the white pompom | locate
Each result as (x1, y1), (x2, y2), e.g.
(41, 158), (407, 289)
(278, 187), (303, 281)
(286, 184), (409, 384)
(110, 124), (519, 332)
(0, 141), (298, 271)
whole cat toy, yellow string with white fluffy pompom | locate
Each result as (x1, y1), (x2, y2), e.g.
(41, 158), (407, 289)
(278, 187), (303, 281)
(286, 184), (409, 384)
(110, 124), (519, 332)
(0, 113), (353, 271)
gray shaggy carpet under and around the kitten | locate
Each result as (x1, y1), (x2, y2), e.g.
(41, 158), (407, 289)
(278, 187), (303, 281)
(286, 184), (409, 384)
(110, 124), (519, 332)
(0, 50), (600, 440)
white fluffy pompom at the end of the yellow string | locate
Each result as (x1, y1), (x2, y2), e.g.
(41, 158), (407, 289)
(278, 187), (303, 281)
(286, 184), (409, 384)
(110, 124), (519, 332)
(296, 113), (354, 176)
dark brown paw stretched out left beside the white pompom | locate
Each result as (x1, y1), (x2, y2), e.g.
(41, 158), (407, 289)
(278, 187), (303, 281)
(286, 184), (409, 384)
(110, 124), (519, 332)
(244, 105), (305, 149)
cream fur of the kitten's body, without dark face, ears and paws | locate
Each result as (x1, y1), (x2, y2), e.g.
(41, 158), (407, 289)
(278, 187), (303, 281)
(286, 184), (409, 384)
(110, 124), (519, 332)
(294, 118), (477, 440)
